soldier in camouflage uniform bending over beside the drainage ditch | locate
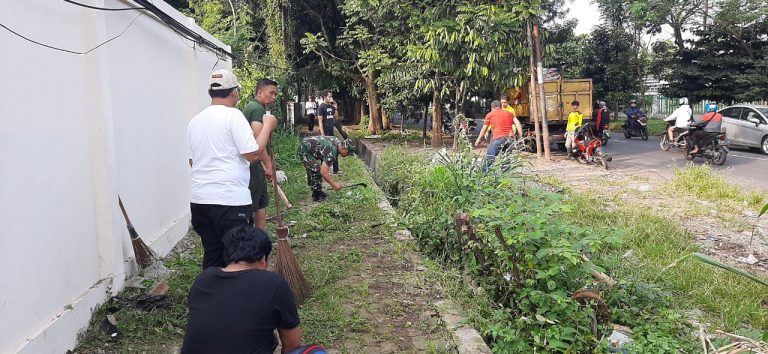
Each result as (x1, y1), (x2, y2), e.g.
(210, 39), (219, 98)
(299, 136), (355, 202)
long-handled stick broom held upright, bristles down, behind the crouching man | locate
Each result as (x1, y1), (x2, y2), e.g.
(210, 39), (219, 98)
(267, 111), (311, 304)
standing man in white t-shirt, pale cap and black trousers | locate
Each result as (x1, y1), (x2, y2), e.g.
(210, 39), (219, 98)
(187, 69), (277, 269)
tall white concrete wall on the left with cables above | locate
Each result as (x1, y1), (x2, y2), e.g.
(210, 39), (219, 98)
(0, 0), (231, 354)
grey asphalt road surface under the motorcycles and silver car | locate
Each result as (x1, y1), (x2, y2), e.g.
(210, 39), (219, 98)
(603, 132), (768, 190)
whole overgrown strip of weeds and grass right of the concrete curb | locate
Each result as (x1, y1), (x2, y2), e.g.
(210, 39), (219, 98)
(376, 140), (768, 353)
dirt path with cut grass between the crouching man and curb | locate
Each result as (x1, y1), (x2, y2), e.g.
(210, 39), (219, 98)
(272, 165), (456, 354)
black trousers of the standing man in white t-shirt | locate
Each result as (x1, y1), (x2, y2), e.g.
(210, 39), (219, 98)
(189, 203), (253, 269)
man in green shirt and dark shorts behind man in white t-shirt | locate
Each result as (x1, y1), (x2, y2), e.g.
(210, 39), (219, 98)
(243, 79), (277, 230)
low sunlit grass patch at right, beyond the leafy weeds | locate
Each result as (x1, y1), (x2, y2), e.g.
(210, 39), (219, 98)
(566, 195), (768, 331)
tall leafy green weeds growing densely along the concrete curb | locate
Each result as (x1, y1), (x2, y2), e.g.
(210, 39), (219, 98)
(379, 143), (632, 353)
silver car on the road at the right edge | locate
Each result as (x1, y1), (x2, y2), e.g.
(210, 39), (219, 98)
(719, 105), (768, 154)
